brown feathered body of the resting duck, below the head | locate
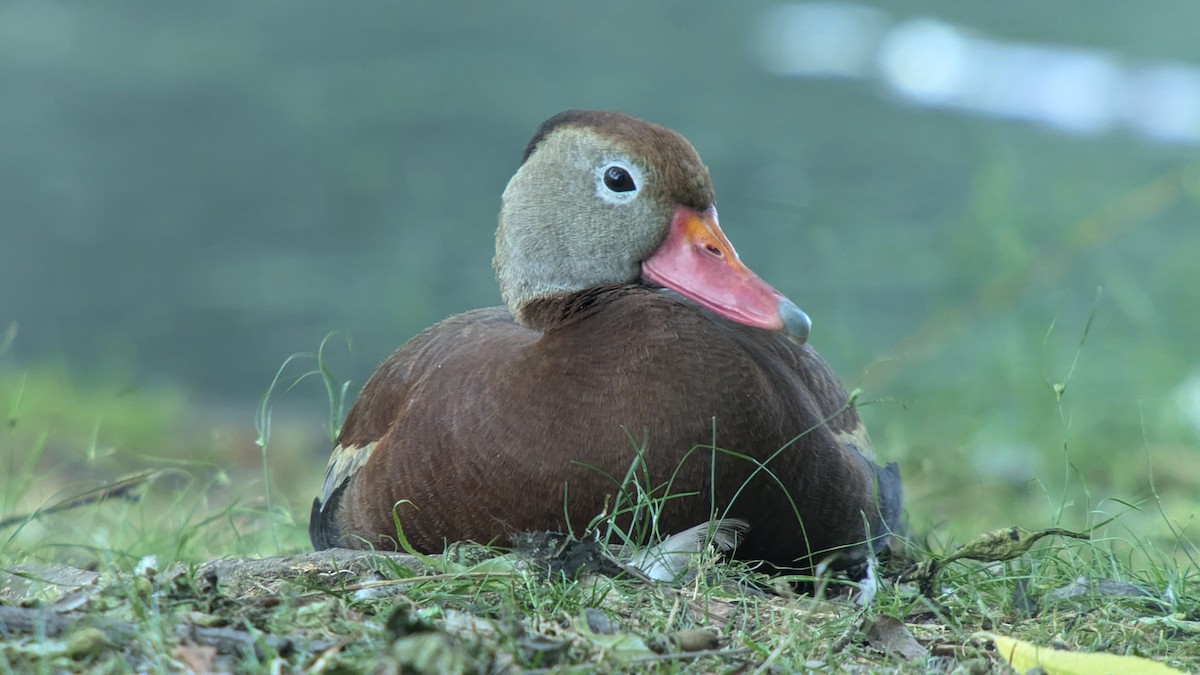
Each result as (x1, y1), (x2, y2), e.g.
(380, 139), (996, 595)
(314, 285), (900, 568)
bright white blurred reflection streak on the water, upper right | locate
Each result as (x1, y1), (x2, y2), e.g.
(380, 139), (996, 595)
(751, 2), (1200, 143)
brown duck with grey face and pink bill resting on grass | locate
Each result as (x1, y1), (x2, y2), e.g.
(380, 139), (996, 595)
(310, 109), (902, 572)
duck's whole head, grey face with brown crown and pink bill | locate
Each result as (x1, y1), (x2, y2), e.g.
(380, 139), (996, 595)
(492, 110), (811, 342)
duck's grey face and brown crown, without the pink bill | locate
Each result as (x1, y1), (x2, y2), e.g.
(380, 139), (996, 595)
(493, 115), (712, 317)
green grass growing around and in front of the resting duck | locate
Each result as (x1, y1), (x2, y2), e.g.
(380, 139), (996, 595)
(0, 318), (1200, 673)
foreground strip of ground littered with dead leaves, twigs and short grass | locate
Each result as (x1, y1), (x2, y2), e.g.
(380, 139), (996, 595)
(0, 531), (1200, 674)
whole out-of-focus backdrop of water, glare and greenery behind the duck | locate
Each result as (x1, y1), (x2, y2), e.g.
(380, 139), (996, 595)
(0, 0), (1200, 557)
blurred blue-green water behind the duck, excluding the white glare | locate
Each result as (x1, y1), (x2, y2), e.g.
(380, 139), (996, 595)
(0, 0), (1200, 425)
